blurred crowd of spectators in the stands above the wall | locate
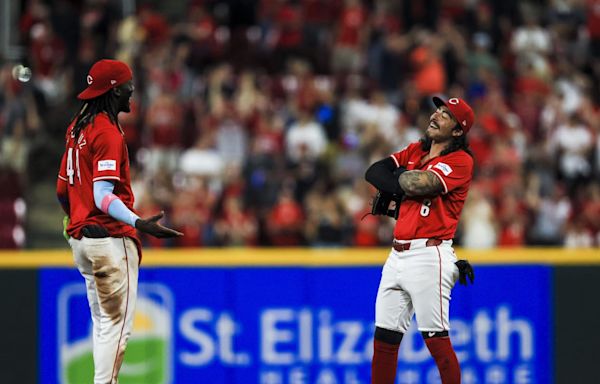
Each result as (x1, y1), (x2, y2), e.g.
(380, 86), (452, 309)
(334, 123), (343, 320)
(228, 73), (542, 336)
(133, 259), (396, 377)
(0, 0), (600, 248)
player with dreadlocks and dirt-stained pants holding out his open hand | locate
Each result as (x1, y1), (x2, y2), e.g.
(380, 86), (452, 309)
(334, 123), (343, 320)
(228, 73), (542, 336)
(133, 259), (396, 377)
(56, 60), (182, 384)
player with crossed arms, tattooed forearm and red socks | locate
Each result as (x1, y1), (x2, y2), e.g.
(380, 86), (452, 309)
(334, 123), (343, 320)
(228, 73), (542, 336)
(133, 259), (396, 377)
(365, 97), (474, 384)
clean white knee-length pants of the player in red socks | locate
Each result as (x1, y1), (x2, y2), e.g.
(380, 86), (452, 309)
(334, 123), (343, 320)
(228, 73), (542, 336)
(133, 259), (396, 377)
(375, 239), (459, 333)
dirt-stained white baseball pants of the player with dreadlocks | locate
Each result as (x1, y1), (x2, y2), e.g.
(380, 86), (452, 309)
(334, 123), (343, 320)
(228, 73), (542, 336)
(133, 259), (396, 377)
(69, 237), (139, 384)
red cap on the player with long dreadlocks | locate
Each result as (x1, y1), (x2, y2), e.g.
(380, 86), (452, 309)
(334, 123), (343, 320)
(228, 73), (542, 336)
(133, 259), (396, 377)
(77, 59), (133, 100)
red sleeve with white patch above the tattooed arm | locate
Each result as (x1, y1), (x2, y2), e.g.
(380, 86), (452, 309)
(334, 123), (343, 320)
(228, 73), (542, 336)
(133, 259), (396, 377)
(428, 152), (473, 193)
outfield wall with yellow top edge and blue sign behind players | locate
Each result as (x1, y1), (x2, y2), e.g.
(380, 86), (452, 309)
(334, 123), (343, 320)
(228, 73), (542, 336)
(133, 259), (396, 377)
(0, 249), (600, 384)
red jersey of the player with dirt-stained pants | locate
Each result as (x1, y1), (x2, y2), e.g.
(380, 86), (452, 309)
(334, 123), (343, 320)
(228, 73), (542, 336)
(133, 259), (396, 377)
(58, 113), (137, 239)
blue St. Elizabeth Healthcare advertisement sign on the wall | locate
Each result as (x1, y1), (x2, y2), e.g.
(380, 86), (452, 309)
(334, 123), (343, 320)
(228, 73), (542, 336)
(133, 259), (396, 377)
(39, 266), (552, 384)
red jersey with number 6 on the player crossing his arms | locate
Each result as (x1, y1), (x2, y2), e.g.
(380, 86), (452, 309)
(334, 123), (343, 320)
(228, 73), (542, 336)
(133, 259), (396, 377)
(392, 143), (473, 240)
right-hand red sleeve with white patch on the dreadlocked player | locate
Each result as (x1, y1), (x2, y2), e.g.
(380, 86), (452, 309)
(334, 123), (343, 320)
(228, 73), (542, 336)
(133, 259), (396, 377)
(92, 127), (124, 181)
